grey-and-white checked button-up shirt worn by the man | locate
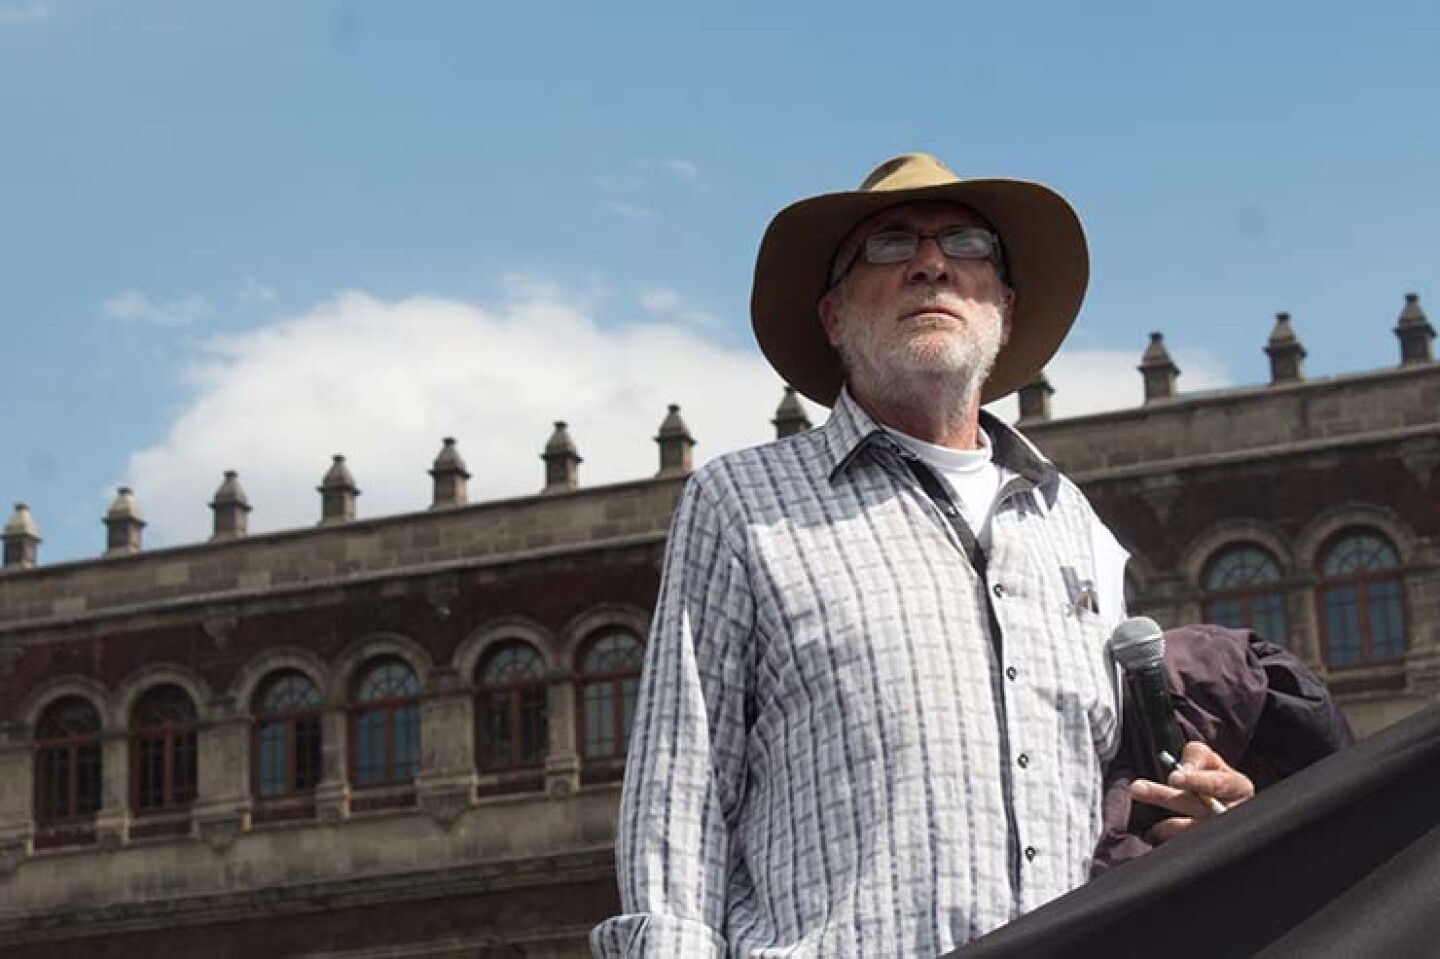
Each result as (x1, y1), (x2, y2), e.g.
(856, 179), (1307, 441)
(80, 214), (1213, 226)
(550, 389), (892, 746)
(590, 393), (1125, 959)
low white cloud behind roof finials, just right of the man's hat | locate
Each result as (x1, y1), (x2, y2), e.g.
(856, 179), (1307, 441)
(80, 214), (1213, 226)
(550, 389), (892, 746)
(988, 344), (1230, 422)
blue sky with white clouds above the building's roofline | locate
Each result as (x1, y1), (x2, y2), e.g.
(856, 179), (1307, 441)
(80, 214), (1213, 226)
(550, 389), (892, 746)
(0, 0), (1440, 563)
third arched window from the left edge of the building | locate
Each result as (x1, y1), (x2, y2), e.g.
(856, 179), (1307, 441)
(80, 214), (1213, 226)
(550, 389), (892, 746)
(251, 670), (321, 799)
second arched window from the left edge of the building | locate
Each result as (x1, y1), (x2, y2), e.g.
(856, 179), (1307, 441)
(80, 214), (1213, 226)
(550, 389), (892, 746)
(130, 685), (196, 814)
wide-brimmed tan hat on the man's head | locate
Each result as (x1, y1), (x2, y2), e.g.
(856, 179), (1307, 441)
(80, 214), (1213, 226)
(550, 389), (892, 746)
(750, 153), (1090, 406)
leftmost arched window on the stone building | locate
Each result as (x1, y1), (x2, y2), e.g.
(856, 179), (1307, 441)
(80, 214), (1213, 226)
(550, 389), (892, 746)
(35, 695), (102, 822)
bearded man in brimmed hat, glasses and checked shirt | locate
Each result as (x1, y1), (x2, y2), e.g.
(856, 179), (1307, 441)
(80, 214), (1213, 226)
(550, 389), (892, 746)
(592, 154), (1250, 959)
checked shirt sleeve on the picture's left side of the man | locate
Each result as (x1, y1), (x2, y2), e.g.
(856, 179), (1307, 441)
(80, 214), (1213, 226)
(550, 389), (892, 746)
(590, 472), (755, 959)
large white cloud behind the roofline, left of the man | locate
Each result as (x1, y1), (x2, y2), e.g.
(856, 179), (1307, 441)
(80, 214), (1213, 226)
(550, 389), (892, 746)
(127, 288), (821, 546)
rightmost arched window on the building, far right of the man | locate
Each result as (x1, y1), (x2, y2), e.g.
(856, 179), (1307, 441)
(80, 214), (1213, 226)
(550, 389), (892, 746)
(1319, 530), (1405, 668)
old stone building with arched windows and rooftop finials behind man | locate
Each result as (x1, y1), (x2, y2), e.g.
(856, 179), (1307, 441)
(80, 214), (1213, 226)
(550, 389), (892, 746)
(0, 297), (1440, 959)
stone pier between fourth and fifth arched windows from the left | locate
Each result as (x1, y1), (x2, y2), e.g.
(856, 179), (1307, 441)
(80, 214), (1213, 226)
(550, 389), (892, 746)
(415, 667), (475, 828)
